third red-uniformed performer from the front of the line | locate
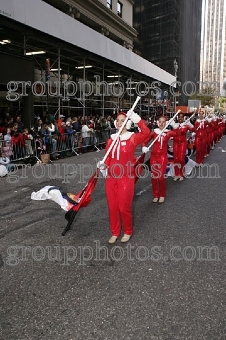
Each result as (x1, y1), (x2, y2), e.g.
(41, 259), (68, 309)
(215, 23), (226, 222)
(173, 112), (194, 181)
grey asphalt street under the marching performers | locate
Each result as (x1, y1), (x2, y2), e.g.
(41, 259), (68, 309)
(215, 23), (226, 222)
(0, 137), (226, 340)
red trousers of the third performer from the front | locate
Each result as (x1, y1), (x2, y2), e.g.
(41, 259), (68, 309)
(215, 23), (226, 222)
(173, 141), (187, 177)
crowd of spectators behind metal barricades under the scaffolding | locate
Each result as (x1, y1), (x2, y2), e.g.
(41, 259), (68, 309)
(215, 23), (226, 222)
(0, 108), (165, 168)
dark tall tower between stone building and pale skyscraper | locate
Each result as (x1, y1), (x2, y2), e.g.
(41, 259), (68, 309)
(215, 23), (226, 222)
(134, 0), (202, 105)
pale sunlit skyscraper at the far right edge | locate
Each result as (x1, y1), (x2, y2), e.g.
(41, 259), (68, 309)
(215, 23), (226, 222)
(200, 0), (226, 93)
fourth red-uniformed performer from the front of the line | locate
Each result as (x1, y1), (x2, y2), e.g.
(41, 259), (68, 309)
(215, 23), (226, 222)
(194, 109), (207, 164)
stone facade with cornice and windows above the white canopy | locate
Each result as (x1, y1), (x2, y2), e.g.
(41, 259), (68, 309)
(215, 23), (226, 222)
(45, 0), (137, 50)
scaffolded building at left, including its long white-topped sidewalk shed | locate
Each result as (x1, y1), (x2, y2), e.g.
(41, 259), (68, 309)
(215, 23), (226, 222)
(0, 0), (175, 122)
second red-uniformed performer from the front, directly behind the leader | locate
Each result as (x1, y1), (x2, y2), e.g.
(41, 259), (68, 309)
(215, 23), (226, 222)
(142, 116), (181, 203)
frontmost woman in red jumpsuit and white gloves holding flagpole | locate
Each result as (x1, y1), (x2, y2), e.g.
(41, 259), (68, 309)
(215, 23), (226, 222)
(97, 110), (150, 244)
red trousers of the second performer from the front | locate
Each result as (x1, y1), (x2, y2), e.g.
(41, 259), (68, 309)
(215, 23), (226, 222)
(150, 154), (168, 198)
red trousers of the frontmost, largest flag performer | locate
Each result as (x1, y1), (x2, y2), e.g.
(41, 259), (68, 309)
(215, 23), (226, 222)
(105, 176), (134, 236)
